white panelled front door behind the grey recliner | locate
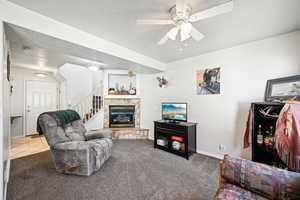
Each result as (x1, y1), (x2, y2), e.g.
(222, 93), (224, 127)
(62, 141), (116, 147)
(25, 81), (58, 135)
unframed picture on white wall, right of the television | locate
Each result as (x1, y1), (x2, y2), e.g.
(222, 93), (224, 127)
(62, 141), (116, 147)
(196, 67), (221, 95)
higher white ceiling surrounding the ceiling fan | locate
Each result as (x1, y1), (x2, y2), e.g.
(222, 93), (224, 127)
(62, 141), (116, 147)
(10, 0), (300, 62)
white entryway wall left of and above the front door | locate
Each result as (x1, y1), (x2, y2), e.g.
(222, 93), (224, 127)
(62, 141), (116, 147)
(11, 67), (58, 138)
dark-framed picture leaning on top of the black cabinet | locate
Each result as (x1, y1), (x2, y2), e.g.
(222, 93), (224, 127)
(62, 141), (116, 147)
(265, 75), (300, 101)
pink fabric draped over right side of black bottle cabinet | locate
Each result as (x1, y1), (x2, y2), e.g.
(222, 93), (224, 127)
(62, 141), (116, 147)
(275, 103), (300, 172)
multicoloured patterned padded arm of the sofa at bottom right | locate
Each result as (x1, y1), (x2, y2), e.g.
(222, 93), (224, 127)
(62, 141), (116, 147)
(221, 155), (300, 199)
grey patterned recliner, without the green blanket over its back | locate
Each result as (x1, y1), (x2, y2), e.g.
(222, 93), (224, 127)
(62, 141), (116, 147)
(38, 113), (113, 176)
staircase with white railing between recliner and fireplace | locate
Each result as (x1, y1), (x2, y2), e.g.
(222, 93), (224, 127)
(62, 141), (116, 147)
(71, 85), (103, 123)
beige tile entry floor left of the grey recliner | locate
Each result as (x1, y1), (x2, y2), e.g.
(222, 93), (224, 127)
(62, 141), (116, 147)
(10, 135), (49, 159)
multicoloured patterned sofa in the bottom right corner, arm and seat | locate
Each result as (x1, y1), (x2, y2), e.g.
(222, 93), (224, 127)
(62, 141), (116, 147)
(214, 156), (300, 200)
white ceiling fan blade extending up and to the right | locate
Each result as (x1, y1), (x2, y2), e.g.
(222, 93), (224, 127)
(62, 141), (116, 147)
(189, 0), (233, 22)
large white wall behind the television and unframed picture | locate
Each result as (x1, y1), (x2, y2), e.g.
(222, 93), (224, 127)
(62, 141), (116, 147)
(163, 32), (300, 157)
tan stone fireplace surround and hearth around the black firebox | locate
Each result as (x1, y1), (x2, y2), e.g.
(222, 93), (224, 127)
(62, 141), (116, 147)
(103, 98), (149, 139)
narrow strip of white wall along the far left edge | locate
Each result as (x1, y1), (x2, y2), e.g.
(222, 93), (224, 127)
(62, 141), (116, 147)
(0, 20), (10, 199)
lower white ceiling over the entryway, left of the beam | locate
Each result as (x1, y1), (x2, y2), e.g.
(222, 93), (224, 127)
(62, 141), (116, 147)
(5, 24), (162, 73)
